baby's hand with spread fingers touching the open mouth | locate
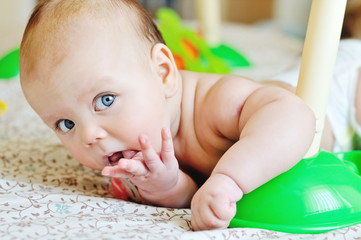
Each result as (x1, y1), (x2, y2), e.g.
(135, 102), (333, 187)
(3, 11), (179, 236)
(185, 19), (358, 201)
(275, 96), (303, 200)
(102, 129), (179, 203)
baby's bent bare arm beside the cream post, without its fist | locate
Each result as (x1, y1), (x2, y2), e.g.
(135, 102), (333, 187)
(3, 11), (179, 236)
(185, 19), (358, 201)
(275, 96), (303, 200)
(213, 86), (315, 193)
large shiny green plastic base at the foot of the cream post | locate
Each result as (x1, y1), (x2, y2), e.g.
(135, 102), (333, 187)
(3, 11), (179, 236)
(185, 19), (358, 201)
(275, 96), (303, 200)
(229, 151), (361, 233)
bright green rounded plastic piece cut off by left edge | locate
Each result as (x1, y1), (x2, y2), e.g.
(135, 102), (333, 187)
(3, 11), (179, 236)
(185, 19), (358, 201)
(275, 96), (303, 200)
(0, 48), (19, 80)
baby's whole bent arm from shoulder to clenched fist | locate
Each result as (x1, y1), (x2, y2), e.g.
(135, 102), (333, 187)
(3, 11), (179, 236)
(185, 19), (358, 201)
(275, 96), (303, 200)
(191, 78), (315, 230)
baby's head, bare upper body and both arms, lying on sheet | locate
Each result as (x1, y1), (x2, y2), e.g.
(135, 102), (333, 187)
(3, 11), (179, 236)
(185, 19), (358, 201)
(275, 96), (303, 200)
(20, 0), (322, 230)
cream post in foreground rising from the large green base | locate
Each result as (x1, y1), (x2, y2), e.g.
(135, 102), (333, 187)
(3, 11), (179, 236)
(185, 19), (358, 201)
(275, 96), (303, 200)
(296, 0), (347, 157)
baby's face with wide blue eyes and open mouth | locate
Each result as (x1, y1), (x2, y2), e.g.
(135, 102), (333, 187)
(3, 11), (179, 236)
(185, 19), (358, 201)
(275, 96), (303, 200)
(23, 20), (170, 170)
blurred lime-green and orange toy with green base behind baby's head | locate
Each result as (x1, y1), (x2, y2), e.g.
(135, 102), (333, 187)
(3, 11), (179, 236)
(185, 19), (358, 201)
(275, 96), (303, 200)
(157, 8), (250, 74)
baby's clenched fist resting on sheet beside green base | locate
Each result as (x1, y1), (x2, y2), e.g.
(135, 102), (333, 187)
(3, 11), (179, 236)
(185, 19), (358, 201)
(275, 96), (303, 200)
(191, 174), (243, 231)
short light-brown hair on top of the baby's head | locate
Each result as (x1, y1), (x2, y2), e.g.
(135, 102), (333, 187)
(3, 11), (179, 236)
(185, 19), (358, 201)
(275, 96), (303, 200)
(20, 0), (164, 78)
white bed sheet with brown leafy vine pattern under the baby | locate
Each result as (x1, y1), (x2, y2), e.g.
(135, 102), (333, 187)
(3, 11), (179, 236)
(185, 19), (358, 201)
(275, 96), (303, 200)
(0, 25), (361, 240)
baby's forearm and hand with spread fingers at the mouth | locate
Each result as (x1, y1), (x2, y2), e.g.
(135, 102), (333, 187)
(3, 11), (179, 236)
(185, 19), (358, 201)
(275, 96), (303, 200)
(102, 129), (198, 207)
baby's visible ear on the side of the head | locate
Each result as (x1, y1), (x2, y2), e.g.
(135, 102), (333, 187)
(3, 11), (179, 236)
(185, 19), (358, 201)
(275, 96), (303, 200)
(151, 43), (178, 98)
